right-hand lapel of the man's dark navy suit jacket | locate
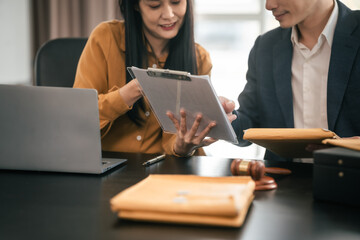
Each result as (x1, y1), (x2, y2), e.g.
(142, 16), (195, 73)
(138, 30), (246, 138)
(327, 2), (360, 130)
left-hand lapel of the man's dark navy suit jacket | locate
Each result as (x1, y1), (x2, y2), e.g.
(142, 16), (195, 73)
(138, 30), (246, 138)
(273, 29), (294, 128)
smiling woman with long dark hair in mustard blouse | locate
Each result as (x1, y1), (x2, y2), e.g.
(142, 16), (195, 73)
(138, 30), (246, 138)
(74, 0), (215, 156)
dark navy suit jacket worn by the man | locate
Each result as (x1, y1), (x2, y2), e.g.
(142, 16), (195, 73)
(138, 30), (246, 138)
(232, 2), (360, 160)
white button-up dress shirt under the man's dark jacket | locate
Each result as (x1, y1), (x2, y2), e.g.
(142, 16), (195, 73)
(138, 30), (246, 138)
(291, 1), (339, 129)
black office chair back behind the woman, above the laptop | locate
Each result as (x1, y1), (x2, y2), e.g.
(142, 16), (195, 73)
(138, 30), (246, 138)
(34, 38), (87, 87)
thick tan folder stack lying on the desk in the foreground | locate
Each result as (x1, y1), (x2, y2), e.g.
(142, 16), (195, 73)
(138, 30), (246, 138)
(110, 175), (255, 227)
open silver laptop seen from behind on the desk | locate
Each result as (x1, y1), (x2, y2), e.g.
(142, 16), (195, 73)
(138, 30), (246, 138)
(0, 85), (127, 174)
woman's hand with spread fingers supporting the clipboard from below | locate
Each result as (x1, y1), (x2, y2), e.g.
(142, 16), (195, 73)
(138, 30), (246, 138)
(166, 109), (217, 156)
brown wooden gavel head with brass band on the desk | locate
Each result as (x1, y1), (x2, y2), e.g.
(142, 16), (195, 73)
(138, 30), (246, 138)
(230, 159), (265, 181)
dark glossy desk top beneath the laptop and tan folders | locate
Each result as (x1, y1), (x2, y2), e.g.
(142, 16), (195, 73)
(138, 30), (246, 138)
(0, 154), (360, 240)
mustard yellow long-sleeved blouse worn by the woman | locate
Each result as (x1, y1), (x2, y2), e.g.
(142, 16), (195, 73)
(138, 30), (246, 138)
(74, 20), (212, 155)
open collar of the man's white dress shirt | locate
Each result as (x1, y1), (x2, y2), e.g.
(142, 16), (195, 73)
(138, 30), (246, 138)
(291, 0), (339, 47)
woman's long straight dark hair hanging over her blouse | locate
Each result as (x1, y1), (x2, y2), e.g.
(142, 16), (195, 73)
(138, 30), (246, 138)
(119, 0), (198, 125)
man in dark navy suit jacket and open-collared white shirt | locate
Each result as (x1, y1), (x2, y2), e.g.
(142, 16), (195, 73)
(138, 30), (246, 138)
(225, 0), (360, 161)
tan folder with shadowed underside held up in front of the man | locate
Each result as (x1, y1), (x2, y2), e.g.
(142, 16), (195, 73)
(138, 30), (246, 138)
(244, 128), (338, 158)
